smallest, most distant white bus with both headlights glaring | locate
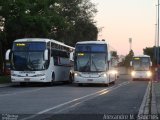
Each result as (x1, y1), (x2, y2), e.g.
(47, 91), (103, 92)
(130, 55), (152, 80)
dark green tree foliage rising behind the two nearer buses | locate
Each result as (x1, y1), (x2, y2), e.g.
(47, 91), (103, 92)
(0, 0), (98, 48)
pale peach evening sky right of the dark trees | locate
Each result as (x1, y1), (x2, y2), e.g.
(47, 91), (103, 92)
(91, 0), (158, 55)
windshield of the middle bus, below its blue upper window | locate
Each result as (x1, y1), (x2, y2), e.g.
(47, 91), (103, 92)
(76, 53), (107, 72)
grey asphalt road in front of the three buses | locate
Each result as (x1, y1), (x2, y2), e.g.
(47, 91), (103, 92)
(0, 75), (148, 120)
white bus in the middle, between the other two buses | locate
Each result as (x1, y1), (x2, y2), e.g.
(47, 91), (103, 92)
(74, 41), (117, 86)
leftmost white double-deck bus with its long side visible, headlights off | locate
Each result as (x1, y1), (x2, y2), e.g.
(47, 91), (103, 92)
(6, 38), (74, 85)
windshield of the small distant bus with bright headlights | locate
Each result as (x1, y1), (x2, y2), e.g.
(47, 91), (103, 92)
(133, 58), (150, 71)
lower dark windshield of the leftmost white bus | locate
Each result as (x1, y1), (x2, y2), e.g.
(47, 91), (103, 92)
(12, 52), (45, 71)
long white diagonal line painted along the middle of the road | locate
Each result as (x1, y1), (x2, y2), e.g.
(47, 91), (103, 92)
(21, 81), (130, 120)
